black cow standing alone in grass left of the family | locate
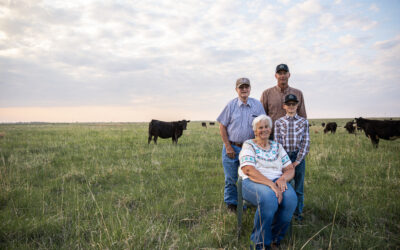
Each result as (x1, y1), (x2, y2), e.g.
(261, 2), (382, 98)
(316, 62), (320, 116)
(148, 120), (190, 144)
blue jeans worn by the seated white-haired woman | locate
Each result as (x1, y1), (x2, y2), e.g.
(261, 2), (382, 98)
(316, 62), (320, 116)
(242, 178), (297, 247)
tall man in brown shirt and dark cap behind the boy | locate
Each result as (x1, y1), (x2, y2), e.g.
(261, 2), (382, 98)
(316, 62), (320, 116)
(260, 64), (307, 132)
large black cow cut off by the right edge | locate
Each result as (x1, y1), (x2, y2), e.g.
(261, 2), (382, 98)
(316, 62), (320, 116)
(356, 117), (400, 148)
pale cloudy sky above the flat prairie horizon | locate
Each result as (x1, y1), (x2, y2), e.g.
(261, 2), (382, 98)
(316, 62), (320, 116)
(0, 0), (400, 123)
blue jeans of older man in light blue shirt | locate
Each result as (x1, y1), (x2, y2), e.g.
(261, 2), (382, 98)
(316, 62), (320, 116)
(222, 144), (242, 205)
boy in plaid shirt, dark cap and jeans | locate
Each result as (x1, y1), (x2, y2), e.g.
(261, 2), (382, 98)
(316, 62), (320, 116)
(275, 94), (310, 221)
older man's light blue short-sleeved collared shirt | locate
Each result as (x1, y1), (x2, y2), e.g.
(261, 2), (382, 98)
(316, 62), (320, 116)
(217, 97), (265, 143)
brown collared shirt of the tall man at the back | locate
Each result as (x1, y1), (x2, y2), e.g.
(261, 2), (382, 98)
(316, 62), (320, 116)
(260, 86), (307, 123)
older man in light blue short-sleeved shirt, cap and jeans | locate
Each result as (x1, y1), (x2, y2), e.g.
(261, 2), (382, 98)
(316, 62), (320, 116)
(217, 78), (265, 212)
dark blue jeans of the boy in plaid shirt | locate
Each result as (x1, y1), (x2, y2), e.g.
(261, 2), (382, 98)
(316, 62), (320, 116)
(288, 152), (306, 215)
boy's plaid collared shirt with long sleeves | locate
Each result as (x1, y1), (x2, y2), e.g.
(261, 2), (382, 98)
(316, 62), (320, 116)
(275, 114), (310, 163)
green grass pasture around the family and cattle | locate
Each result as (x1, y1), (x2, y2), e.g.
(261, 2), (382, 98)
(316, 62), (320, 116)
(0, 120), (400, 249)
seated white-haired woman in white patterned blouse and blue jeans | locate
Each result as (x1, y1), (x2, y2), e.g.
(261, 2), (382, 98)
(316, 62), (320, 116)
(239, 115), (297, 249)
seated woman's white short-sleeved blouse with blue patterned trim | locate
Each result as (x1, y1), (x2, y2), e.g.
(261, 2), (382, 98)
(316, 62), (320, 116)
(239, 140), (292, 181)
